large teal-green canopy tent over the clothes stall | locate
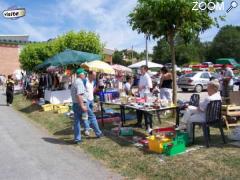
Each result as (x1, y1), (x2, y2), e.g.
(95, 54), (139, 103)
(35, 49), (101, 69)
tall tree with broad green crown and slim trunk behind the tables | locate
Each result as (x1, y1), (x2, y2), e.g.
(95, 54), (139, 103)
(129, 0), (221, 103)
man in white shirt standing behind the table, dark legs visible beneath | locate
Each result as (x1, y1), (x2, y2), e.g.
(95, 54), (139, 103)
(135, 65), (152, 133)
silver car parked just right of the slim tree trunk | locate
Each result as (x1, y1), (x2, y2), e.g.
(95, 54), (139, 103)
(177, 71), (219, 93)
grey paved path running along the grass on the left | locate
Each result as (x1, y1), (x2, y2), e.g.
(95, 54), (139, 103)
(0, 91), (122, 180)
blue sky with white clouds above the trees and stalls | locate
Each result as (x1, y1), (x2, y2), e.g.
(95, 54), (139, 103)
(0, 0), (240, 51)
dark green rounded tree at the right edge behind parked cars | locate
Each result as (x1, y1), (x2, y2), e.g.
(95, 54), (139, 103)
(209, 25), (240, 60)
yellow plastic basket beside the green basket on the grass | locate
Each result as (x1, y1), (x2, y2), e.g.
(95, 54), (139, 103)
(147, 136), (172, 153)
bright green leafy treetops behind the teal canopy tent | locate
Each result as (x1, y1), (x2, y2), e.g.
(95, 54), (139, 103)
(20, 31), (103, 71)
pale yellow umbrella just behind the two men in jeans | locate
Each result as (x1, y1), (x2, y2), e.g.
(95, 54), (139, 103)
(81, 61), (115, 74)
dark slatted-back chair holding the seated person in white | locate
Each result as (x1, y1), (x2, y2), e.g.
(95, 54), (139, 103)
(192, 100), (226, 147)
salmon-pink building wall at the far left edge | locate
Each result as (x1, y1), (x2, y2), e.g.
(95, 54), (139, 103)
(0, 44), (20, 75)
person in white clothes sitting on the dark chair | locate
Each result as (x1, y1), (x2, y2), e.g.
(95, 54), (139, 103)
(182, 79), (221, 139)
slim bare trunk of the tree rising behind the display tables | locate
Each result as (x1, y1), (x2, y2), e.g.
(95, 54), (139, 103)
(168, 33), (177, 105)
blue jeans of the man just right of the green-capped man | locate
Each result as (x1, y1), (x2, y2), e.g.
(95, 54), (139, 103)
(87, 100), (102, 136)
